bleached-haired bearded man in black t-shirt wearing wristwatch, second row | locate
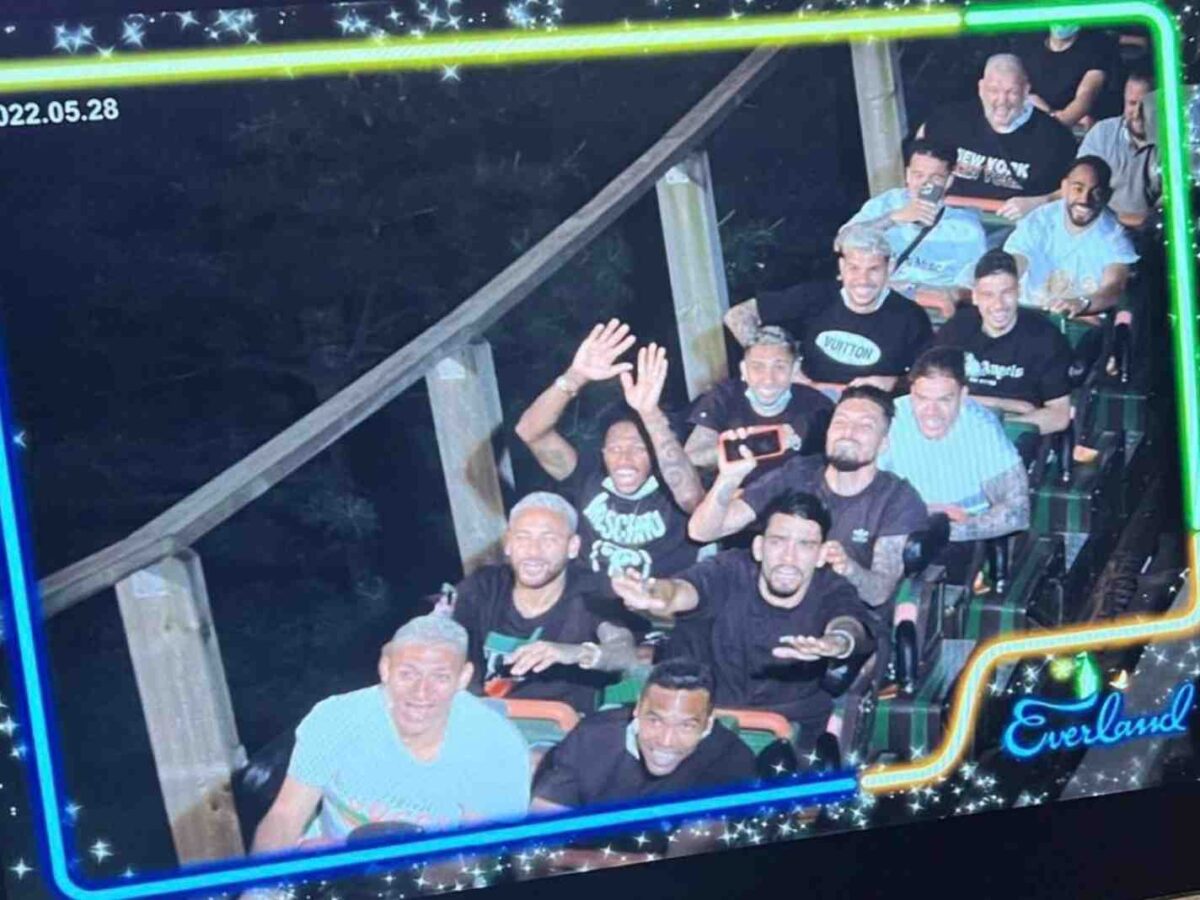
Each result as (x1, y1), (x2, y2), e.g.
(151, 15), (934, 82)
(454, 492), (637, 714)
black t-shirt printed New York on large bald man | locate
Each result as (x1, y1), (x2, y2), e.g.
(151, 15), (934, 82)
(925, 100), (1075, 200)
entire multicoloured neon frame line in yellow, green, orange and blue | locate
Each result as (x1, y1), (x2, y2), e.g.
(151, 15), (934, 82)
(0, 0), (1200, 900)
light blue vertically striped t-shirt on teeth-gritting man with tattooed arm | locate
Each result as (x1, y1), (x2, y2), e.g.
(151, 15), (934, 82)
(878, 397), (1021, 516)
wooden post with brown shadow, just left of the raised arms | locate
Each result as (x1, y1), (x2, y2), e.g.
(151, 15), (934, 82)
(425, 341), (512, 574)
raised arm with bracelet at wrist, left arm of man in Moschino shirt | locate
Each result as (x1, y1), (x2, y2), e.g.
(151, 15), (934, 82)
(516, 319), (637, 481)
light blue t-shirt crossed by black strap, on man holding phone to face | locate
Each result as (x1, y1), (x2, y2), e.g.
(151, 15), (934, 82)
(842, 187), (988, 290)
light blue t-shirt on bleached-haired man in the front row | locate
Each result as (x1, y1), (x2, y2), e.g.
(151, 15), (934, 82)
(288, 685), (529, 839)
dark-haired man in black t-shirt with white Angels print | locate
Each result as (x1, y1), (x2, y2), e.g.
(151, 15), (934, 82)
(935, 252), (1072, 434)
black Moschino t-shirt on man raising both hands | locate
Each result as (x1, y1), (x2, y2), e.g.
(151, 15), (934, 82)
(562, 454), (700, 577)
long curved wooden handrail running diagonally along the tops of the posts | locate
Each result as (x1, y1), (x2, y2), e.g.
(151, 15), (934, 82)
(38, 47), (782, 617)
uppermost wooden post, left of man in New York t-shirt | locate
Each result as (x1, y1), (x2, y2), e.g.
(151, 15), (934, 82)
(850, 41), (908, 197)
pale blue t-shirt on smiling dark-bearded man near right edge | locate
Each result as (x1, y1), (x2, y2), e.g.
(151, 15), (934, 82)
(1004, 200), (1138, 307)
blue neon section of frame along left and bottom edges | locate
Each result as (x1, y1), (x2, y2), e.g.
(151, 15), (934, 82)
(0, 7), (1190, 900)
